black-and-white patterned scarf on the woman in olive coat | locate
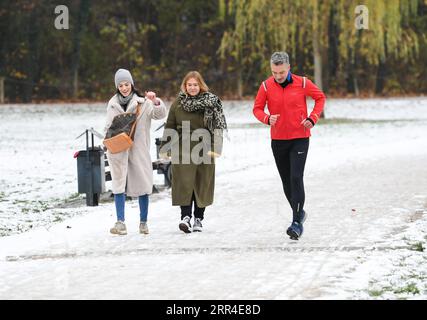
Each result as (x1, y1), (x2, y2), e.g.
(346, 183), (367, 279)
(178, 92), (227, 134)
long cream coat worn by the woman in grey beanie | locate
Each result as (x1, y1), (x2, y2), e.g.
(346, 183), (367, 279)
(104, 94), (166, 197)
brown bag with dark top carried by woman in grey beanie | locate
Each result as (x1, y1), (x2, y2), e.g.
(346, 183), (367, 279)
(103, 104), (141, 153)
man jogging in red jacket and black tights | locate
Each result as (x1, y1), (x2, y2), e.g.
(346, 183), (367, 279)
(253, 52), (326, 240)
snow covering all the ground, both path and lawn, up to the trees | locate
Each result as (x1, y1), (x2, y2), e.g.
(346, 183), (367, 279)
(0, 97), (427, 299)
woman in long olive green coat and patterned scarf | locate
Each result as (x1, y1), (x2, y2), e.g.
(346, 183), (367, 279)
(162, 71), (227, 233)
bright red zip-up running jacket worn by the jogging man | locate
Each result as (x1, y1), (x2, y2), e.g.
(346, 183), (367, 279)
(253, 73), (326, 140)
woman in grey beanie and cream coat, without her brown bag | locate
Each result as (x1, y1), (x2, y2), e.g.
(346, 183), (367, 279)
(104, 69), (166, 235)
